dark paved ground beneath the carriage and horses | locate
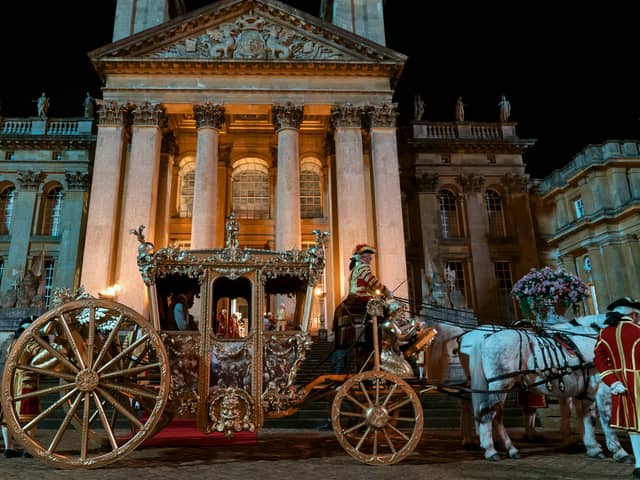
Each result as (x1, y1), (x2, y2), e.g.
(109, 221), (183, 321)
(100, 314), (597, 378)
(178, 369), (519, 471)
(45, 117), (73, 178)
(0, 429), (633, 480)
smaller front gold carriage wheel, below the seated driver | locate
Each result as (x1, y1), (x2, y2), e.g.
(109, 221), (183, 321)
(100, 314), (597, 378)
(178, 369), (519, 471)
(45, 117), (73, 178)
(331, 371), (424, 465)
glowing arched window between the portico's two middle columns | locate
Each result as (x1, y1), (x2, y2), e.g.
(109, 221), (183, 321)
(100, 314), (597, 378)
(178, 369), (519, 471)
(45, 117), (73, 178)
(231, 159), (270, 220)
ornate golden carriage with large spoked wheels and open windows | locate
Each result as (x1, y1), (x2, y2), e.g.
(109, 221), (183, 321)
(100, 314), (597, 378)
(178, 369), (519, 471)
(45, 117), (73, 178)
(1, 227), (432, 468)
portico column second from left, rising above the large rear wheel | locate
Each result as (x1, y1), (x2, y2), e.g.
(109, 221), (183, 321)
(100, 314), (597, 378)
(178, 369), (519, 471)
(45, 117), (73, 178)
(116, 102), (166, 315)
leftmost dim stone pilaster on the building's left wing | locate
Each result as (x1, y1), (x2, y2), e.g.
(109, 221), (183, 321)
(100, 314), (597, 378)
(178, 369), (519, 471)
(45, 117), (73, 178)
(3, 170), (46, 290)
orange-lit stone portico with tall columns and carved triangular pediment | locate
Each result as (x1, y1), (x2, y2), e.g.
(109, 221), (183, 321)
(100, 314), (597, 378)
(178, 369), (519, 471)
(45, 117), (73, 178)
(82, 1), (407, 322)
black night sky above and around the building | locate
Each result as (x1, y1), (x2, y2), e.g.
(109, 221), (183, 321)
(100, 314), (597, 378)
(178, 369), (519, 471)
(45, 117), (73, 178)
(0, 0), (640, 177)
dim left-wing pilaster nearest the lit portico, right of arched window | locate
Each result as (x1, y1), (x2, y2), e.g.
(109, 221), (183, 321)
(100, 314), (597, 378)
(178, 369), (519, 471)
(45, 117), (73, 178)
(53, 171), (91, 288)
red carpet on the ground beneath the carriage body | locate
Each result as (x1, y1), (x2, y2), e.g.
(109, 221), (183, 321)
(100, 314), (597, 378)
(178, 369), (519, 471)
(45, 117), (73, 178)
(142, 418), (257, 447)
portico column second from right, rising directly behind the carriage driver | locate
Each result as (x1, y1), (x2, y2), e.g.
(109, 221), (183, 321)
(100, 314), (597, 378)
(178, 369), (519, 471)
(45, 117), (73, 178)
(331, 103), (373, 297)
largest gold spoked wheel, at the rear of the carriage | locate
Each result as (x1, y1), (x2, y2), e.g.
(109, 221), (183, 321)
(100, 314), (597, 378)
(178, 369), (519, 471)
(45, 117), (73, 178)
(2, 298), (170, 468)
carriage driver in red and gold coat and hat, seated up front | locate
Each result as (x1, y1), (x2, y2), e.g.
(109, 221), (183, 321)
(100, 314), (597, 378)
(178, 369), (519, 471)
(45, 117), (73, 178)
(331, 243), (392, 373)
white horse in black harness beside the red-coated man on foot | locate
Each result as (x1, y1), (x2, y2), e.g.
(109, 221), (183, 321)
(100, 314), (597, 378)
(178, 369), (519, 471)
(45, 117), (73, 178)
(468, 315), (630, 462)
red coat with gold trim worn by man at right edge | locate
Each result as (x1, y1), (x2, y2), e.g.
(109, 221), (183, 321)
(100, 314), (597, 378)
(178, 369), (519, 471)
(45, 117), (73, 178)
(594, 320), (640, 432)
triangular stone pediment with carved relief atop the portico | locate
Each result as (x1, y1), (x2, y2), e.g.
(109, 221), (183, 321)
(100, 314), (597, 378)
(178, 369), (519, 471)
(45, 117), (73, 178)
(89, 0), (406, 77)
